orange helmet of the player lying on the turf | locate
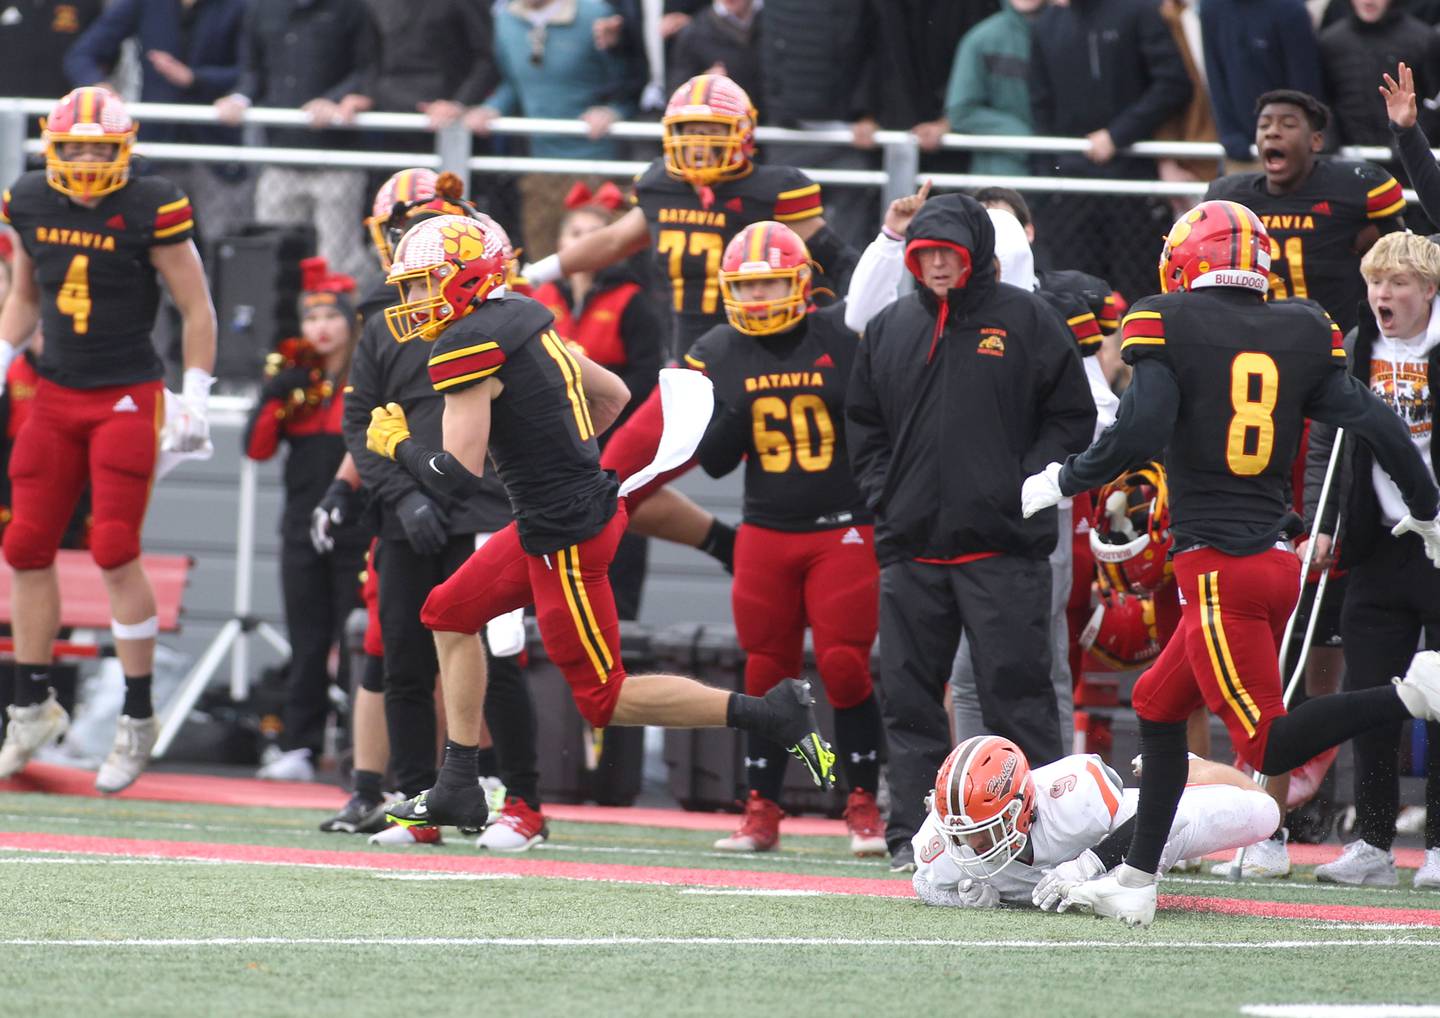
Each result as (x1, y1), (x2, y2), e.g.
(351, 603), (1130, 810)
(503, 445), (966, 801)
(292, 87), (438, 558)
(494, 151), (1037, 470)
(930, 736), (1035, 880)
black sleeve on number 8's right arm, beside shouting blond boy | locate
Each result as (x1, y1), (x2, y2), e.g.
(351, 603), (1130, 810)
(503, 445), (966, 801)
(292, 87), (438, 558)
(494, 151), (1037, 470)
(1306, 364), (1440, 520)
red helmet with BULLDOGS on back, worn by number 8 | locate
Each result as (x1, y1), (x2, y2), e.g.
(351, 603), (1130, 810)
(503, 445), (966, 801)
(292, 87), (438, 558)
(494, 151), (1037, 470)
(1161, 202), (1270, 294)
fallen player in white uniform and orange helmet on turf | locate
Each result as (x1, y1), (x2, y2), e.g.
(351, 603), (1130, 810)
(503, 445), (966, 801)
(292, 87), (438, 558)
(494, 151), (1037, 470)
(912, 736), (1280, 911)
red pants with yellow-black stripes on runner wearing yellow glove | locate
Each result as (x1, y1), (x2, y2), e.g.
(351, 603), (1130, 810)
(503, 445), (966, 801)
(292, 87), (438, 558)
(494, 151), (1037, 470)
(420, 500), (628, 729)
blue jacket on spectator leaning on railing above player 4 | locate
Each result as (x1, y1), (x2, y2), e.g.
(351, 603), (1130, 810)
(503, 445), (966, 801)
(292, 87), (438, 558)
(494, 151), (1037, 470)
(65, 0), (245, 144)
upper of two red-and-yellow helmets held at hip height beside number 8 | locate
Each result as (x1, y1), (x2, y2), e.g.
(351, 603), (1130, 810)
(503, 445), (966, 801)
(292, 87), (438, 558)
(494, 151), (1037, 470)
(1090, 461), (1175, 593)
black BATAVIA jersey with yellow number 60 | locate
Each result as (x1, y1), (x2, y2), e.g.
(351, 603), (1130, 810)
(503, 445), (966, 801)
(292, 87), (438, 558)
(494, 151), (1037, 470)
(685, 304), (871, 531)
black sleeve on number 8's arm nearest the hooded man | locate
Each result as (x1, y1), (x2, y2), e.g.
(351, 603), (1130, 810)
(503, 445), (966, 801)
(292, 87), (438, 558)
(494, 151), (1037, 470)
(1060, 357), (1179, 495)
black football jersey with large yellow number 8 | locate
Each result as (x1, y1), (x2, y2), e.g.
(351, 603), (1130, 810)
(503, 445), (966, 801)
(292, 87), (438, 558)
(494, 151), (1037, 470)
(1120, 289), (1345, 554)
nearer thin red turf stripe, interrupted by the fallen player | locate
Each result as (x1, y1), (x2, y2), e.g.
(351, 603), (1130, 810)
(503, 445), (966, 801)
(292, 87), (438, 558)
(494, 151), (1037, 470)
(0, 834), (1440, 927)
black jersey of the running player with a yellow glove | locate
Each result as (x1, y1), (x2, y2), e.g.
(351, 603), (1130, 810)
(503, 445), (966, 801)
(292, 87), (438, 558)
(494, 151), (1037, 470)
(429, 294), (619, 554)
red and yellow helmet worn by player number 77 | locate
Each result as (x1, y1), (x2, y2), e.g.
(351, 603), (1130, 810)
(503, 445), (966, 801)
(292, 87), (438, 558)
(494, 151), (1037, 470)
(660, 75), (759, 187)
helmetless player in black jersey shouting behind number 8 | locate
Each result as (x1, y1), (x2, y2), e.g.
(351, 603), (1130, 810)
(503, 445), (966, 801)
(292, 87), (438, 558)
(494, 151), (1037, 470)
(1205, 89), (1405, 333)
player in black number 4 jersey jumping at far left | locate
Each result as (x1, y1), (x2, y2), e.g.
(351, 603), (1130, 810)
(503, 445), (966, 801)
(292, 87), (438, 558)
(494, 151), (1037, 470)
(0, 88), (215, 792)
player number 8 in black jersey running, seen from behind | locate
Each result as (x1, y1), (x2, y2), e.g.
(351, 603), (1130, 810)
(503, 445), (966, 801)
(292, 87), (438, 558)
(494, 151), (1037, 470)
(1021, 202), (1440, 926)
